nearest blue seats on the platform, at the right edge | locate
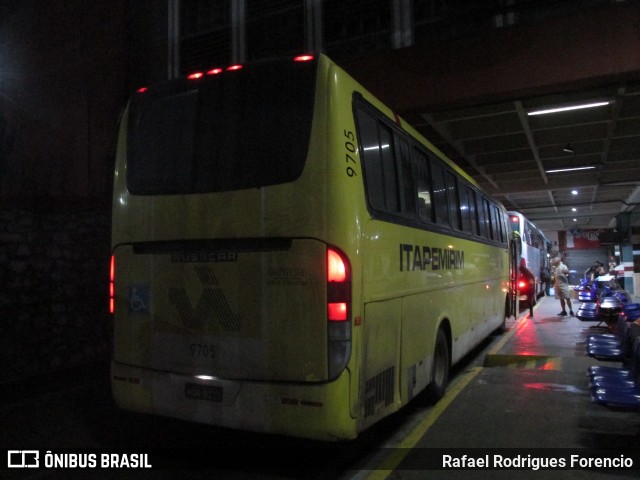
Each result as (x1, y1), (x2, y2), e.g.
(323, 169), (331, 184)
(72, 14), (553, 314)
(586, 315), (640, 410)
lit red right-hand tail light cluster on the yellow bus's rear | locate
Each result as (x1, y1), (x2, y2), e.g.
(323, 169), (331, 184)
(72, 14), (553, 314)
(327, 248), (351, 379)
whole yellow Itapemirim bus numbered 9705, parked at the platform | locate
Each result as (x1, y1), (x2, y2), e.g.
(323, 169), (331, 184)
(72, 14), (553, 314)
(110, 55), (510, 440)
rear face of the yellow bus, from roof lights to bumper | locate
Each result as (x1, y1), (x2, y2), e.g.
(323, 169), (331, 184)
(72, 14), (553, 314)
(111, 57), (363, 439)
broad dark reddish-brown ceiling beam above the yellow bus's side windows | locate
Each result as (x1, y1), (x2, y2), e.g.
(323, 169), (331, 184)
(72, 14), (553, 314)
(341, 2), (640, 115)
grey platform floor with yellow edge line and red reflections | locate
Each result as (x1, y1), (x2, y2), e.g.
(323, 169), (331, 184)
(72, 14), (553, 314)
(360, 297), (640, 480)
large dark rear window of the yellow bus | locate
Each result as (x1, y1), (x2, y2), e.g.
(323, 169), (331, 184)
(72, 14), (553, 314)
(127, 62), (316, 195)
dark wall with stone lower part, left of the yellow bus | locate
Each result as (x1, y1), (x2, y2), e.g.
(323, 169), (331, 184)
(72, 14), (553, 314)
(0, 0), (131, 383)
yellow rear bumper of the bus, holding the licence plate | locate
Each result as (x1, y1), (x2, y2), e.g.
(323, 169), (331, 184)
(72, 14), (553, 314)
(111, 361), (358, 441)
